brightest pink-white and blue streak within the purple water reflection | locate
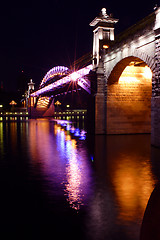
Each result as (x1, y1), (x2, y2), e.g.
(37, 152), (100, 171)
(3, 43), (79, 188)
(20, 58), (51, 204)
(52, 120), (87, 211)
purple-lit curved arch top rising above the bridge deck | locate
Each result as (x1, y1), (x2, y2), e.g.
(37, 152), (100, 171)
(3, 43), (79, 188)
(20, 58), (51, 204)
(40, 66), (69, 87)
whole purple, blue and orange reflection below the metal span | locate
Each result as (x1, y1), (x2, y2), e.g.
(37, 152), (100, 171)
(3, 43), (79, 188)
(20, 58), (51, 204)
(29, 120), (90, 210)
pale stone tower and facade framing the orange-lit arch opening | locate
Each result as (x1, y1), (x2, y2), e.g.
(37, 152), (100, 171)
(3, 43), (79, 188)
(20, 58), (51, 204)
(90, 7), (160, 147)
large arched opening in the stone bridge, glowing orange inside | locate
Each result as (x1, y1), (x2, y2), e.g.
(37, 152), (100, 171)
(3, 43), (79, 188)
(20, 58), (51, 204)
(107, 57), (152, 134)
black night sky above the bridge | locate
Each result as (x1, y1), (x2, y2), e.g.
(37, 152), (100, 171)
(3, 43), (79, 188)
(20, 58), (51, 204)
(0, 0), (160, 90)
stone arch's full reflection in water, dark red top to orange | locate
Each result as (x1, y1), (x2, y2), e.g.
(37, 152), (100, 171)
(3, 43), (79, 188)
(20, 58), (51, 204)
(107, 135), (155, 222)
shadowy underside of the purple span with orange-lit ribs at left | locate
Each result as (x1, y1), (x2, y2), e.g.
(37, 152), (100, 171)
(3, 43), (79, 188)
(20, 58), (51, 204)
(29, 82), (89, 118)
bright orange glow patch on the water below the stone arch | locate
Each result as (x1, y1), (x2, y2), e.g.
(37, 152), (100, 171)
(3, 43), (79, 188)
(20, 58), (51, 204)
(110, 155), (153, 221)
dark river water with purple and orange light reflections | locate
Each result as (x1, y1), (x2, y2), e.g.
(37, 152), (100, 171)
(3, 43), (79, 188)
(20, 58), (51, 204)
(0, 119), (160, 240)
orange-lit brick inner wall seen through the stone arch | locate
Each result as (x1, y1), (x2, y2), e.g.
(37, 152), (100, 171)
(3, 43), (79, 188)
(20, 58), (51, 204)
(107, 63), (152, 133)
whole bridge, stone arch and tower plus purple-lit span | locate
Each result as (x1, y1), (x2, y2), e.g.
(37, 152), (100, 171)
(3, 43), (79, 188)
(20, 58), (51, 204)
(27, 8), (160, 147)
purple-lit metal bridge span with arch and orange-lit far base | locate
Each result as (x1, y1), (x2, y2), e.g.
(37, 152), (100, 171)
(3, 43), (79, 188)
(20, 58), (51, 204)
(29, 64), (93, 117)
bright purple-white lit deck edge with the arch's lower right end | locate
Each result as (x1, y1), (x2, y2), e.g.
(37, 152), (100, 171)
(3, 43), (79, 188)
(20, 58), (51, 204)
(31, 64), (93, 97)
